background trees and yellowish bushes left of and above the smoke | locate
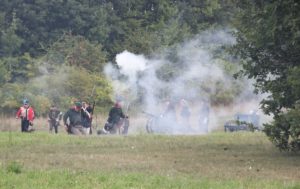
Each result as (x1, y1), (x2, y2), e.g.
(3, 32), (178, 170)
(0, 0), (237, 114)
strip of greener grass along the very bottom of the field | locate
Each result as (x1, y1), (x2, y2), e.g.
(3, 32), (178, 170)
(0, 170), (299, 189)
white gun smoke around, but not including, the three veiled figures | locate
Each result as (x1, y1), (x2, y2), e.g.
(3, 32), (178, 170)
(105, 31), (270, 134)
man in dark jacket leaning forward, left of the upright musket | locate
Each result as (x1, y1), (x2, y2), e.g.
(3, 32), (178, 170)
(63, 102), (86, 135)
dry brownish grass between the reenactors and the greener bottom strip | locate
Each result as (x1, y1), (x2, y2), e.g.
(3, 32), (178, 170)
(0, 132), (300, 181)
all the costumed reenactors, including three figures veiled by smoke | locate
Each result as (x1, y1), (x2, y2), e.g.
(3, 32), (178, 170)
(16, 96), (209, 135)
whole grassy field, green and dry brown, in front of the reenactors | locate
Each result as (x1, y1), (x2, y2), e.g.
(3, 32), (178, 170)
(0, 132), (300, 189)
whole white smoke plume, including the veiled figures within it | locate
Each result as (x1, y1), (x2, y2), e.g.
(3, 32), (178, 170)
(105, 31), (268, 134)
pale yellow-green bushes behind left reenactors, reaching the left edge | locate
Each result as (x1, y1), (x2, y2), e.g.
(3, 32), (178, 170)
(0, 67), (112, 116)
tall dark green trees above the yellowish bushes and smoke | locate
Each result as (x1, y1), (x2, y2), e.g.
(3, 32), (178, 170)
(0, 0), (233, 60)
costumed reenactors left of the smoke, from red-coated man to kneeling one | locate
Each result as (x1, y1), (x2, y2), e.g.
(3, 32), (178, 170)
(16, 99), (129, 135)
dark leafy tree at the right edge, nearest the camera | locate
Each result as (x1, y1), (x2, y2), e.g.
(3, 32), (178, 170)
(235, 0), (300, 151)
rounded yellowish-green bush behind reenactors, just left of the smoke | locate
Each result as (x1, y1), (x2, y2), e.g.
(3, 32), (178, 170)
(26, 66), (112, 115)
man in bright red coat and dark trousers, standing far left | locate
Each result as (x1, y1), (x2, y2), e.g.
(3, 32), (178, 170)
(16, 99), (34, 132)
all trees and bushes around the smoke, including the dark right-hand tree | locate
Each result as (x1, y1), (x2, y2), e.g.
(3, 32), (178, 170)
(0, 0), (300, 150)
